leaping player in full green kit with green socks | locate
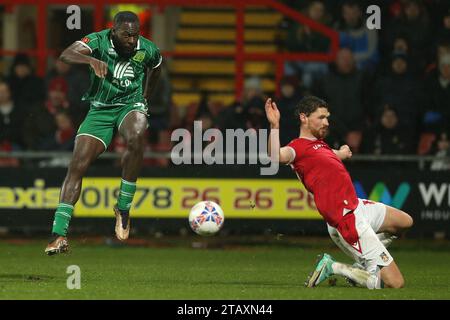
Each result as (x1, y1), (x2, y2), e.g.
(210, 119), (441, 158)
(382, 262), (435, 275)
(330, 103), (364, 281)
(45, 11), (162, 255)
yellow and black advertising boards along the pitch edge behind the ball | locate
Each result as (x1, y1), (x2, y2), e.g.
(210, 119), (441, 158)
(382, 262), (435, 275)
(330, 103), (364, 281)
(0, 164), (450, 237)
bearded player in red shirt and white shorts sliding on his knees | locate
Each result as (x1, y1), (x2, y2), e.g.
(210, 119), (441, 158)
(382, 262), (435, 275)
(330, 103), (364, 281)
(265, 96), (413, 289)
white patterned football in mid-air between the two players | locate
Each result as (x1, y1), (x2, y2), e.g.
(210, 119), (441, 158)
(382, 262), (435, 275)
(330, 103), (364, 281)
(189, 201), (225, 236)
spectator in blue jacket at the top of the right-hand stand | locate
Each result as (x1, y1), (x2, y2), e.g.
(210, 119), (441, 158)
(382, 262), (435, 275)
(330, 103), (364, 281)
(335, 0), (379, 70)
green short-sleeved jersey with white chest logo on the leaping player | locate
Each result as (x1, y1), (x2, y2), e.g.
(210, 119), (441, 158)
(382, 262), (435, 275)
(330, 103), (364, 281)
(78, 29), (162, 107)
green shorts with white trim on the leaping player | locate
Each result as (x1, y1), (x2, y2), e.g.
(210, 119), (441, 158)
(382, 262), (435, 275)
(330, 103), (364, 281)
(77, 102), (148, 150)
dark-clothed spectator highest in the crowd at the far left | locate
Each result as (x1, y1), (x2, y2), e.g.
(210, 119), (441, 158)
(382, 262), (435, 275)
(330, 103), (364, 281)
(8, 54), (45, 111)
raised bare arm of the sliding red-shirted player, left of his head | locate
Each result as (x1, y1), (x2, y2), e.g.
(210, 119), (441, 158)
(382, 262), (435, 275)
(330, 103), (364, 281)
(265, 98), (294, 164)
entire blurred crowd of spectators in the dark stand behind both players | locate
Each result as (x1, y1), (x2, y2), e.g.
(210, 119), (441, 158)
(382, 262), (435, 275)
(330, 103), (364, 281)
(0, 0), (450, 169)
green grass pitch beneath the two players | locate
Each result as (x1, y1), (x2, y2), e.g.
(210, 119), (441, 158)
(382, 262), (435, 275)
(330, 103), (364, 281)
(0, 238), (450, 300)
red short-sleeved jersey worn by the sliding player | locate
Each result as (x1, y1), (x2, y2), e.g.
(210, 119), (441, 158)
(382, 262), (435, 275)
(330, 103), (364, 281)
(288, 138), (358, 227)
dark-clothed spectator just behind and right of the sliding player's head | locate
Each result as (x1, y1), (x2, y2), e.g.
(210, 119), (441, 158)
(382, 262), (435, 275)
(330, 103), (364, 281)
(313, 49), (365, 153)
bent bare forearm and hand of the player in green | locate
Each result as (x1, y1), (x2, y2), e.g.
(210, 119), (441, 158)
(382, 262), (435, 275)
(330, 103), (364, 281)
(59, 42), (108, 78)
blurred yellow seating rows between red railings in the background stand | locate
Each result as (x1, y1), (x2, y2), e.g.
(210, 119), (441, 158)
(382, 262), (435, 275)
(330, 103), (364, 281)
(170, 6), (282, 107)
